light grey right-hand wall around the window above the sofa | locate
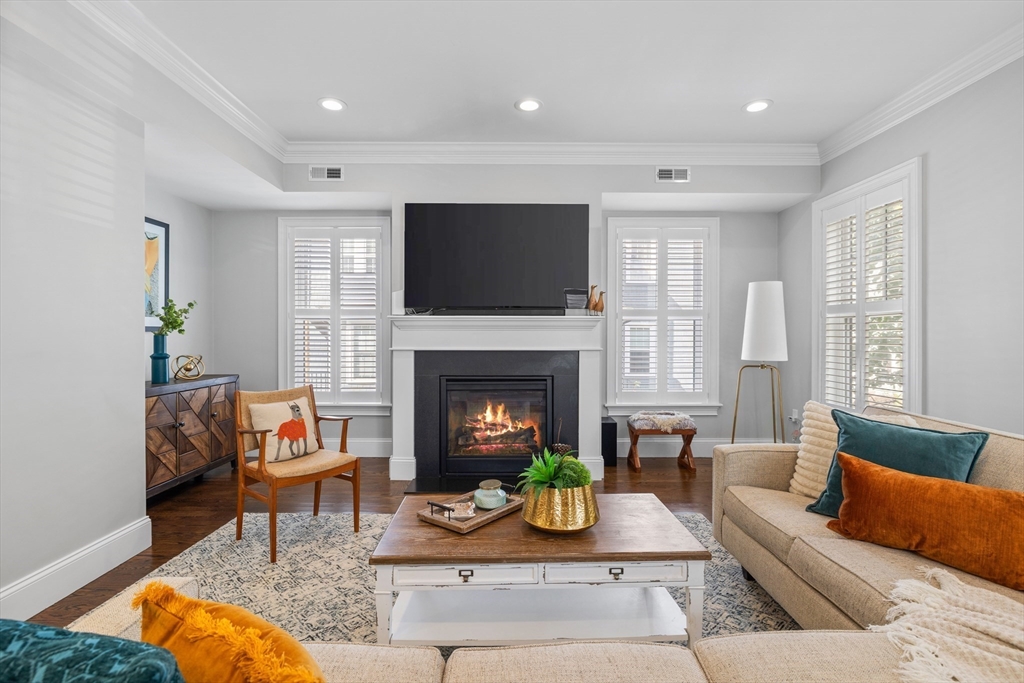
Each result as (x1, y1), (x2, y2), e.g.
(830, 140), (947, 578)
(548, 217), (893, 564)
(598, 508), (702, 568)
(779, 59), (1024, 433)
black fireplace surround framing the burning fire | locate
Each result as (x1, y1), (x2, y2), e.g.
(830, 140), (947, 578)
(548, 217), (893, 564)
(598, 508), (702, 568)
(414, 351), (580, 483)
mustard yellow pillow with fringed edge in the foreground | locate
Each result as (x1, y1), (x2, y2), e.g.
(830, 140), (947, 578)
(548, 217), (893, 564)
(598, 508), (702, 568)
(132, 581), (324, 683)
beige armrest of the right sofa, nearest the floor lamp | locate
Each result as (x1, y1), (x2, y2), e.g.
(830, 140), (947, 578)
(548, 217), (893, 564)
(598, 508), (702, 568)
(712, 443), (800, 543)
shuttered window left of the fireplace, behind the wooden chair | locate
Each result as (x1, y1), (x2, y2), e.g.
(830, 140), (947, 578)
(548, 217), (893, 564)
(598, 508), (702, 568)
(280, 218), (390, 404)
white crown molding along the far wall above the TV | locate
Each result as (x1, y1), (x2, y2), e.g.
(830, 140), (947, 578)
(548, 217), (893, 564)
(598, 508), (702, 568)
(285, 142), (819, 166)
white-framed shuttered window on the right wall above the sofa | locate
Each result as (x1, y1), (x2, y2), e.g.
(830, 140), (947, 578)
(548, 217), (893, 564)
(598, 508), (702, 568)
(812, 159), (921, 412)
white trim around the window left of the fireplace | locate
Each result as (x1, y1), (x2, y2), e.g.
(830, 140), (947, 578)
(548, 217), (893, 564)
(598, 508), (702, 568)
(278, 216), (391, 416)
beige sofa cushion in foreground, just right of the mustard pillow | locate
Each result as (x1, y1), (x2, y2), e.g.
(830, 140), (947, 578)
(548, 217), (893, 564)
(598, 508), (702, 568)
(303, 643), (444, 683)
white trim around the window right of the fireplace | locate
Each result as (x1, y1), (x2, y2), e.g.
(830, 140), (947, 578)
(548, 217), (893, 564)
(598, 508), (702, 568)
(605, 216), (722, 416)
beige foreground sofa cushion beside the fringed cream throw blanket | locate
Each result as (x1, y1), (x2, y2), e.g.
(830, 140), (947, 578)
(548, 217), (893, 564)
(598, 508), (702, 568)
(694, 631), (902, 683)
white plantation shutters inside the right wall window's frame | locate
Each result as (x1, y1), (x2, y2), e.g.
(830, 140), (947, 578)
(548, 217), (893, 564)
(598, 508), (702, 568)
(819, 183), (906, 410)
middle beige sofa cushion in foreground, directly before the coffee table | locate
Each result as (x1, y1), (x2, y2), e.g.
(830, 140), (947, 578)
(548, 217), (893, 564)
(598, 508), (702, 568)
(444, 641), (708, 683)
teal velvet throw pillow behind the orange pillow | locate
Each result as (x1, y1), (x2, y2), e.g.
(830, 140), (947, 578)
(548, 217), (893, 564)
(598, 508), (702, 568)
(807, 411), (988, 518)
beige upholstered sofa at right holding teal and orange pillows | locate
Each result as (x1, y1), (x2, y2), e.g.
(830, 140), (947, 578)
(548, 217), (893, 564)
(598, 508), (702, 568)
(712, 408), (1024, 629)
